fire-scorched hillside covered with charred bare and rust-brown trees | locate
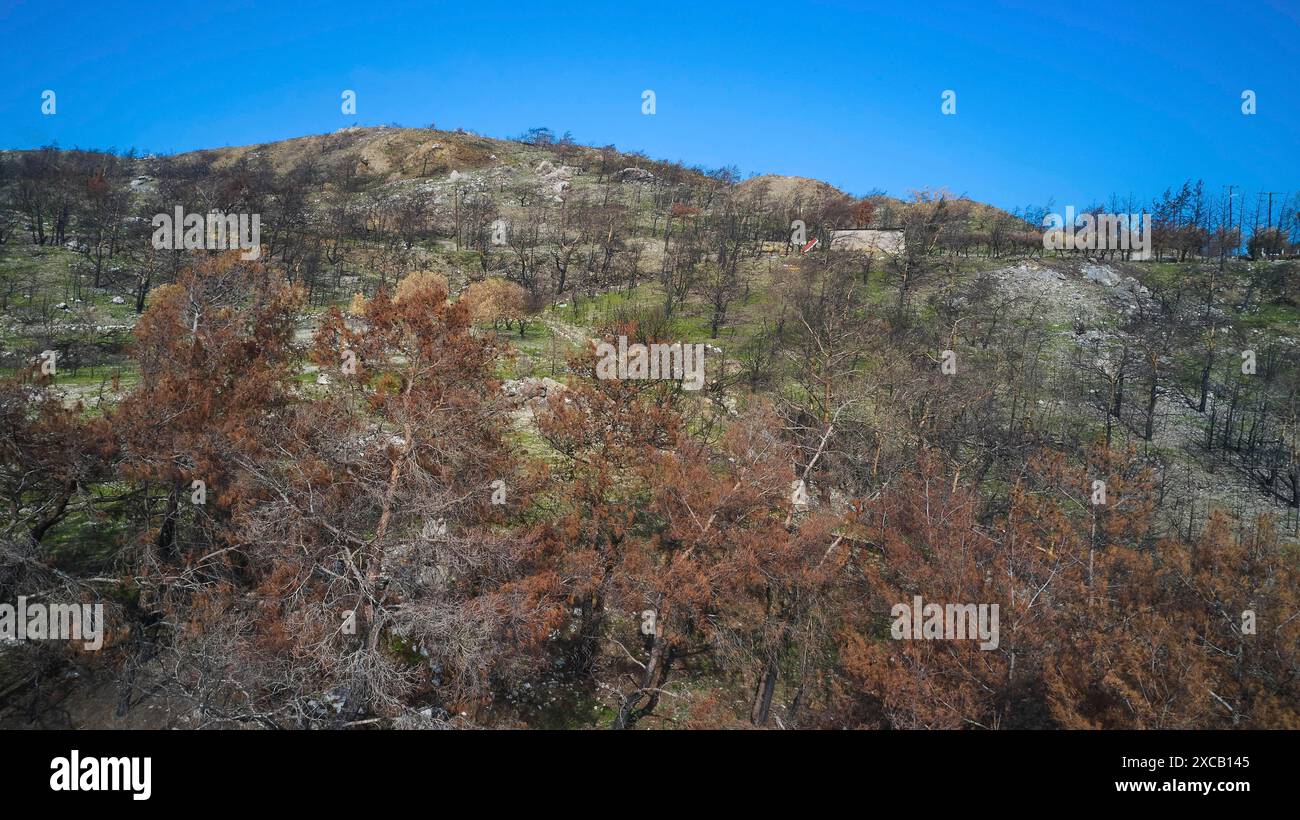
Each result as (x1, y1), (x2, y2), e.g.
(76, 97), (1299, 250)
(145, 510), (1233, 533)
(0, 127), (1300, 729)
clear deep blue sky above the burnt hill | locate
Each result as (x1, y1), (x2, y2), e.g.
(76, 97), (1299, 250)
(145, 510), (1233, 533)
(0, 0), (1300, 213)
